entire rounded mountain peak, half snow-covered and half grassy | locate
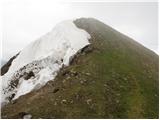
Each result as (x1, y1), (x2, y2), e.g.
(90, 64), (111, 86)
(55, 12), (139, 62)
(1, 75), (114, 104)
(1, 18), (159, 118)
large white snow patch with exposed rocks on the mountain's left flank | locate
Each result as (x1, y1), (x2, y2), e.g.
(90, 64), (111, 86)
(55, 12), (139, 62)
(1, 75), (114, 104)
(1, 20), (90, 102)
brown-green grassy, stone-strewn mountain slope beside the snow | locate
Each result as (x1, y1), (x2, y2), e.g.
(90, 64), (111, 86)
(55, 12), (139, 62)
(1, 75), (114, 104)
(2, 19), (159, 118)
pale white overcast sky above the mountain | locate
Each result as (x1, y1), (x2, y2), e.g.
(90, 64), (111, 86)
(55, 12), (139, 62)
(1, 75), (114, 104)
(2, 0), (158, 60)
